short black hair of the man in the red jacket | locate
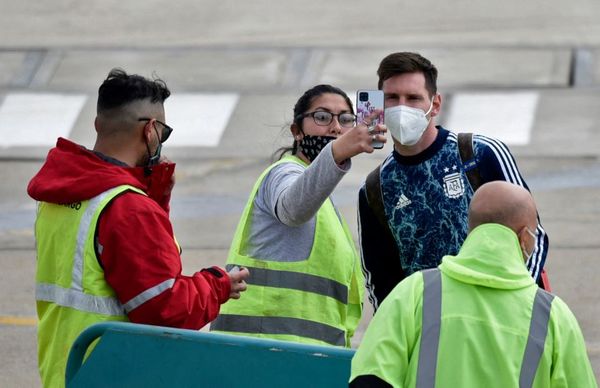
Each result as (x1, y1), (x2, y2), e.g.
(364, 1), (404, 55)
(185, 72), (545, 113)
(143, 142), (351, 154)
(96, 68), (171, 113)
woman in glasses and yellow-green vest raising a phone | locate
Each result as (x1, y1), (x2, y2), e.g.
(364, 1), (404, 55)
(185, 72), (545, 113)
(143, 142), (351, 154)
(211, 85), (386, 347)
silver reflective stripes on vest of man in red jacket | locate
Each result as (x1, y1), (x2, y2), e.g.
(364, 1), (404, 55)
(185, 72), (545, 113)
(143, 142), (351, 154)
(35, 188), (125, 315)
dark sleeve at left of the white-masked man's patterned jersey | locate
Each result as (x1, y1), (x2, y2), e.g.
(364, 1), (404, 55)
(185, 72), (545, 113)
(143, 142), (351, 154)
(358, 186), (404, 310)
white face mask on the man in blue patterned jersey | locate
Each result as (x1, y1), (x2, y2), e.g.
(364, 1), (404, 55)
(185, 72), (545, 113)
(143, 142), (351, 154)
(385, 98), (433, 146)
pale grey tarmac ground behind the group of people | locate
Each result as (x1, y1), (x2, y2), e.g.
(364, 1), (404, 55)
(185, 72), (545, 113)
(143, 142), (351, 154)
(0, 0), (600, 387)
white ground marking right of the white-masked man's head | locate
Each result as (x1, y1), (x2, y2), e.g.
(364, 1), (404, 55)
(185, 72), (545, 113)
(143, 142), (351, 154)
(443, 92), (539, 145)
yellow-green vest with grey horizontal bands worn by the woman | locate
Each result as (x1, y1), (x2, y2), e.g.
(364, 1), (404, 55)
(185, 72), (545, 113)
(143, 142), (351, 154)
(211, 156), (362, 346)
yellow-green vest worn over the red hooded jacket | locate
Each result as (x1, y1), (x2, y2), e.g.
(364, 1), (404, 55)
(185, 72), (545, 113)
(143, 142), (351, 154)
(35, 185), (145, 387)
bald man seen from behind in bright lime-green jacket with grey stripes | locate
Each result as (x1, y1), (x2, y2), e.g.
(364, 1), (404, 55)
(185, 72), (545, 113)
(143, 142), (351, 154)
(350, 181), (597, 388)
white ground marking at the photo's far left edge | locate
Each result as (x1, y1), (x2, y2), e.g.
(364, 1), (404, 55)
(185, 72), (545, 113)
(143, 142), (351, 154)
(0, 93), (87, 147)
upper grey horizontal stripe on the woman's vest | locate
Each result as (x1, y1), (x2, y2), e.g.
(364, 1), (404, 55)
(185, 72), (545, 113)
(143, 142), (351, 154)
(225, 264), (348, 304)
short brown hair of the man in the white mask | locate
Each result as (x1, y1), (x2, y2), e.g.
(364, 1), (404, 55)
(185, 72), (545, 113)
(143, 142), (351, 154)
(377, 52), (437, 96)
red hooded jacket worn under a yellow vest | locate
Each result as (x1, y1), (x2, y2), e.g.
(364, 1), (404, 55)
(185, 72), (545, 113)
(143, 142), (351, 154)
(27, 138), (231, 329)
